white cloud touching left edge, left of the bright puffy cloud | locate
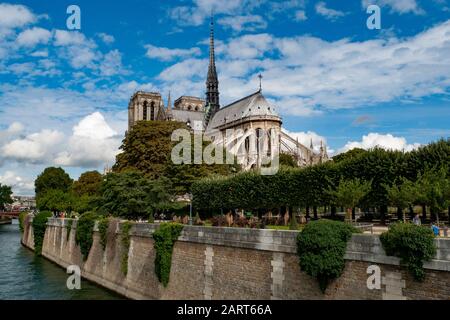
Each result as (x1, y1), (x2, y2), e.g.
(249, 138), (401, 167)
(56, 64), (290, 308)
(1, 129), (64, 163)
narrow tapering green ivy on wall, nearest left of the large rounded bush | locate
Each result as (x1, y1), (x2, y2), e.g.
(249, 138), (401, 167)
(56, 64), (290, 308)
(153, 223), (183, 287)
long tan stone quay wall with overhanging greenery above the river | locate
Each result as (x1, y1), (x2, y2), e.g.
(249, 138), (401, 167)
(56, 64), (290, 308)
(22, 219), (450, 300)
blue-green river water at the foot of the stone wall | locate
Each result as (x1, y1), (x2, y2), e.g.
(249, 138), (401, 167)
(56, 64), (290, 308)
(0, 220), (121, 300)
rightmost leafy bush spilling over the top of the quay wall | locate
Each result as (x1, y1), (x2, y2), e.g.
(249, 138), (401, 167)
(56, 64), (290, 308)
(380, 223), (436, 281)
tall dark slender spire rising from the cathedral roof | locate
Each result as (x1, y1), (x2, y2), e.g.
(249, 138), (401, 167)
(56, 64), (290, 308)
(205, 10), (220, 125)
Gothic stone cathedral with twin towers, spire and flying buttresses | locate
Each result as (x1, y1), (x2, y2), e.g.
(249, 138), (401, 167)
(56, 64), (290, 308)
(128, 15), (329, 169)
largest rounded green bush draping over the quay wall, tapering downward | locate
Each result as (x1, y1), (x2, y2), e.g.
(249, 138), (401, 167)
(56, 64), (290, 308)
(297, 220), (357, 292)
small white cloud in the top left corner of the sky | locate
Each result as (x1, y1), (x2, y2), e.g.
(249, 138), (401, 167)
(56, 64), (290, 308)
(0, 3), (37, 28)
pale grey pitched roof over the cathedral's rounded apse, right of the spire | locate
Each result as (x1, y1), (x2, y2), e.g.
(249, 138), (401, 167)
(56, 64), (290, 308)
(208, 91), (281, 129)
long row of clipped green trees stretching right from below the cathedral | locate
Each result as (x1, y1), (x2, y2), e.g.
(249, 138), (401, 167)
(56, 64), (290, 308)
(192, 140), (450, 222)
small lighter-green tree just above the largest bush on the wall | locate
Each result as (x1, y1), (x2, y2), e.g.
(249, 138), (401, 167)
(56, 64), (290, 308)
(328, 178), (371, 219)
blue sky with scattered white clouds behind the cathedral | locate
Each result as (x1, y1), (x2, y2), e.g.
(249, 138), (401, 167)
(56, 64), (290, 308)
(0, 0), (450, 195)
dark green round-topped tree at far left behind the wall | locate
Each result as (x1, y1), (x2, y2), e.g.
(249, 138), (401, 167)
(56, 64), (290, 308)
(34, 167), (72, 198)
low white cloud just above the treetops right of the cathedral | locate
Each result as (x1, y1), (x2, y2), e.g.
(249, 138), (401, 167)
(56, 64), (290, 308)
(339, 133), (420, 153)
